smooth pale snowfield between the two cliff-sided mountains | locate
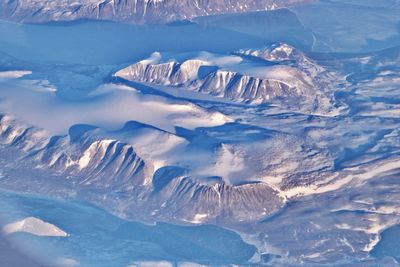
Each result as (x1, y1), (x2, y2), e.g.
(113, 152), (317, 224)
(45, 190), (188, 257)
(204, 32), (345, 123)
(0, 75), (232, 134)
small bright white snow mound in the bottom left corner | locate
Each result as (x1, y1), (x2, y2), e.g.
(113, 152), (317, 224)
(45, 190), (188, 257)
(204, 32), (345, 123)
(3, 217), (68, 237)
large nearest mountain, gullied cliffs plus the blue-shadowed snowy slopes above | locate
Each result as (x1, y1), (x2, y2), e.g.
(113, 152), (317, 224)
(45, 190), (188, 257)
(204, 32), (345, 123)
(0, 102), (333, 223)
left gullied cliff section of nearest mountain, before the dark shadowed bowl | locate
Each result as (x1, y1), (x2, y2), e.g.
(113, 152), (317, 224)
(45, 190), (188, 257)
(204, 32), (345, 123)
(0, 116), (145, 187)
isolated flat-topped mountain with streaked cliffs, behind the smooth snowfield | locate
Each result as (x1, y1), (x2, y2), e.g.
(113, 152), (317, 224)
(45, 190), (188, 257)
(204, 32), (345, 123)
(115, 44), (343, 115)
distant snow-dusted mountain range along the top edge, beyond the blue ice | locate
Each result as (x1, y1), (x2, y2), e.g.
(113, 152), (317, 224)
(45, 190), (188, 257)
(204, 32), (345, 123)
(0, 0), (310, 23)
